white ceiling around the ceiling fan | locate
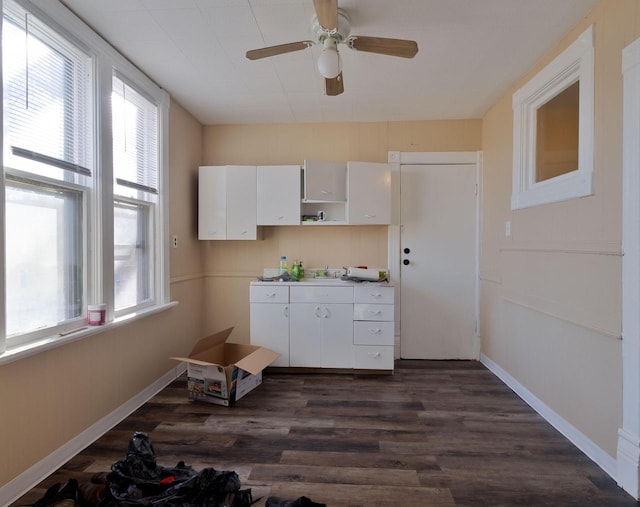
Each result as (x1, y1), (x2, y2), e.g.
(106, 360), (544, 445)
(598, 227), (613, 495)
(57, 0), (598, 125)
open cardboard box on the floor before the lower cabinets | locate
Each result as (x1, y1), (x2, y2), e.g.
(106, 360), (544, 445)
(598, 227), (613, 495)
(171, 327), (280, 406)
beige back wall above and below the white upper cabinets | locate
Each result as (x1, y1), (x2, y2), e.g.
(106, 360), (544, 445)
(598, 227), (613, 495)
(203, 120), (482, 343)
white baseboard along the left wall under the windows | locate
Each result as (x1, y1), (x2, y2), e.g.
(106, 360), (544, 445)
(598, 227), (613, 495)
(0, 363), (187, 505)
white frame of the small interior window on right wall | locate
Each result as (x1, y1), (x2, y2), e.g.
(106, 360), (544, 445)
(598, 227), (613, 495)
(511, 25), (595, 210)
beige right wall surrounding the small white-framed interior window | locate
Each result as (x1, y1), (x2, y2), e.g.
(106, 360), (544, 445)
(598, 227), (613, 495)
(480, 0), (640, 457)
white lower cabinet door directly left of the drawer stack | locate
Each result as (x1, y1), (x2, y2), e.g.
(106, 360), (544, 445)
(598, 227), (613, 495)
(321, 304), (353, 368)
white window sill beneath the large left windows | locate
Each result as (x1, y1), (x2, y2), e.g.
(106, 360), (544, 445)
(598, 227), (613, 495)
(0, 301), (178, 366)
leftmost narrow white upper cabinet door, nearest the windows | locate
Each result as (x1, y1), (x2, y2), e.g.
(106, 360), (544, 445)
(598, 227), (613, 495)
(198, 166), (227, 239)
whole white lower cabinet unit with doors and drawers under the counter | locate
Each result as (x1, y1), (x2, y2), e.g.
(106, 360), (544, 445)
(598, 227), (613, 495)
(250, 282), (394, 370)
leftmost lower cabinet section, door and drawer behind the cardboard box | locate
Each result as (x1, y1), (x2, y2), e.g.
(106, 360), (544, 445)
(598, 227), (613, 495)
(249, 285), (290, 366)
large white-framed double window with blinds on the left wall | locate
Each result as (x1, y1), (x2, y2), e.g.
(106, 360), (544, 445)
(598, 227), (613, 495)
(0, 0), (168, 353)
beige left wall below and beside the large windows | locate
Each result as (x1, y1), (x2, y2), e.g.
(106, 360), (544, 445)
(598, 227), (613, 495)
(0, 98), (202, 484)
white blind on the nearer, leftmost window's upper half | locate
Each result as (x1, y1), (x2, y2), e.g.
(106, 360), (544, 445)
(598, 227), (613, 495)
(2, 2), (93, 176)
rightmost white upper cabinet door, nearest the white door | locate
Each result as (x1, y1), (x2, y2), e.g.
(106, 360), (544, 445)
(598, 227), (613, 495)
(347, 162), (391, 224)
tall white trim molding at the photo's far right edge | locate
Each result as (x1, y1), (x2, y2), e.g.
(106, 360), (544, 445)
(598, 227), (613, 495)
(617, 32), (640, 499)
